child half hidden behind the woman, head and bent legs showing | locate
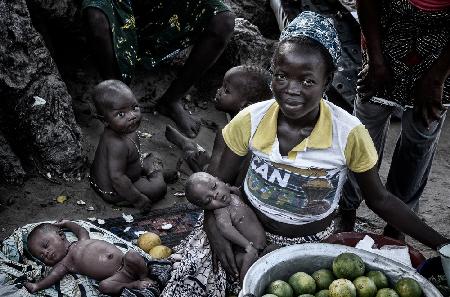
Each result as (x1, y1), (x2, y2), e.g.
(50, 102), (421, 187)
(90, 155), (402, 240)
(166, 65), (273, 172)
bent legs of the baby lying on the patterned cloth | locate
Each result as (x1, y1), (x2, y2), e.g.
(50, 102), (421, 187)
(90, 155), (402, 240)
(99, 250), (156, 294)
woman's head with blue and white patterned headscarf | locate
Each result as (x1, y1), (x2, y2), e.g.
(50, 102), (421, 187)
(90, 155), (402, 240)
(271, 11), (341, 119)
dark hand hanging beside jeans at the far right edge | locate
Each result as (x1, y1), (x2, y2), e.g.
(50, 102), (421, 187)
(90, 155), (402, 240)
(414, 72), (446, 127)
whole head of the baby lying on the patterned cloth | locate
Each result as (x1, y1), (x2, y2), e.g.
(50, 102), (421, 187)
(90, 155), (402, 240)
(27, 223), (69, 266)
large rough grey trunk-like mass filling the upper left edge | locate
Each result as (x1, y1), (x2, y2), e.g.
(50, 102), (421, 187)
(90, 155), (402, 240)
(0, 0), (84, 182)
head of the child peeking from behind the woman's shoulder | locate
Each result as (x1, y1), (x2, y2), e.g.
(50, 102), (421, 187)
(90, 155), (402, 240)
(215, 65), (272, 114)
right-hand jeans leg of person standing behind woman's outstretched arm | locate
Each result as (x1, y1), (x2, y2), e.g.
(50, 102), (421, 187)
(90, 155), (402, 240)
(384, 109), (445, 238)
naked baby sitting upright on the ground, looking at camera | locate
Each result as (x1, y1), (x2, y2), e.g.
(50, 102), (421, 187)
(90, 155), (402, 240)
(90, 80), (171, 212)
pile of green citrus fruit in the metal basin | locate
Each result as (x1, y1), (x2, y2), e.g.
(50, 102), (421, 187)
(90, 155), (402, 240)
(263, 253), (422, 297)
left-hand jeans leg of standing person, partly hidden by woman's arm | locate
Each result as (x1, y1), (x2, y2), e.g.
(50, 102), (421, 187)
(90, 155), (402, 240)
(338, 98), (395, 232)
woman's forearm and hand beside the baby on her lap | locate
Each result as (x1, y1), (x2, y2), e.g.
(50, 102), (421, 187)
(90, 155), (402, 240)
(203, 211), (239, 278)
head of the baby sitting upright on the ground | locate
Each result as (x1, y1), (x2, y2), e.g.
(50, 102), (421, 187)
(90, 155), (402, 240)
(93, 80), (141, 134)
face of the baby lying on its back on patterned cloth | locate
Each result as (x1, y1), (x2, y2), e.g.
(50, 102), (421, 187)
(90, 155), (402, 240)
(28, 231), (67, 266)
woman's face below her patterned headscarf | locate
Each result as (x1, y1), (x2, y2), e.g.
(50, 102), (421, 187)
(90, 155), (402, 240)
(272, 41), (330, 120)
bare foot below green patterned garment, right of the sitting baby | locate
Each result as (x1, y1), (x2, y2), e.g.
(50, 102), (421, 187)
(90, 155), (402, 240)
(157, 101), (200, 138)
